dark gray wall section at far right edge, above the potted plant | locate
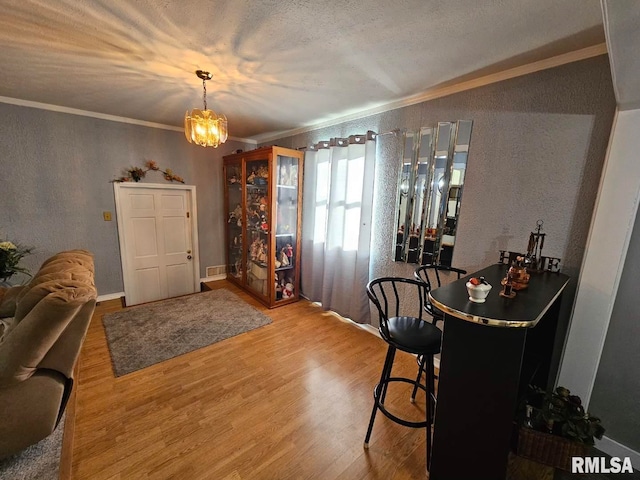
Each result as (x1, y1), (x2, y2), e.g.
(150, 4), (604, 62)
(589, 203), (640, 454)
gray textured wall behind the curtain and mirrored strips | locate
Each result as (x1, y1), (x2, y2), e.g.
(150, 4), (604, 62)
(262, 56), (616, 336)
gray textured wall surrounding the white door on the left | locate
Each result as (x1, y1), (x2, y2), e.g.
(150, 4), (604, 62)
(0, 104), (252, 295)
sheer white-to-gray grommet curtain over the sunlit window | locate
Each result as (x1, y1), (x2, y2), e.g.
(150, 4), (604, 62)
(301, 132), (376, 323)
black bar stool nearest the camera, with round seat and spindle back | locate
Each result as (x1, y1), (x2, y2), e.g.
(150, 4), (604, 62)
(364, 277), (442, 470)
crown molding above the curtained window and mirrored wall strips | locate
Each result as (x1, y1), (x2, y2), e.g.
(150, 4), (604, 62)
(252, 43), (607, 143)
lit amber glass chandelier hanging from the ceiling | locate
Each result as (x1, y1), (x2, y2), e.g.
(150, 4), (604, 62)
(184, 70), (228, 148)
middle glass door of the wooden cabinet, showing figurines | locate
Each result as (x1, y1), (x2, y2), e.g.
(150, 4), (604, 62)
(244, 159), (270, 298)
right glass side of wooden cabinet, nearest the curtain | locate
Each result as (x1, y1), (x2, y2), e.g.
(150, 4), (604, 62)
(271, 155), (300, 302)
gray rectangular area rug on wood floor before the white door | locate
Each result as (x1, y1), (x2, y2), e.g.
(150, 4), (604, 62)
(102, 288), (271, 377)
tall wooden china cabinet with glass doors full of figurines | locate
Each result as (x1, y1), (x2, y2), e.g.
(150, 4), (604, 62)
(224, 147), (304, 308)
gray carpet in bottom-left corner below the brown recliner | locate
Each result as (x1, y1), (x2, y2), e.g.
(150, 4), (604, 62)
(0, 414), (66, 480)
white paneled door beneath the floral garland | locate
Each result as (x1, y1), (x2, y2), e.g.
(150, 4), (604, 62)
(114, 184), (199, 305)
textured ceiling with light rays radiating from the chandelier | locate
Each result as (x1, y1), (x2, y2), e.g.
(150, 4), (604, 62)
(0, 0), (604, 138)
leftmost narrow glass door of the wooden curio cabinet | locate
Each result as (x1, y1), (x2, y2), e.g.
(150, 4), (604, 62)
(224, 162), (244, 281)
